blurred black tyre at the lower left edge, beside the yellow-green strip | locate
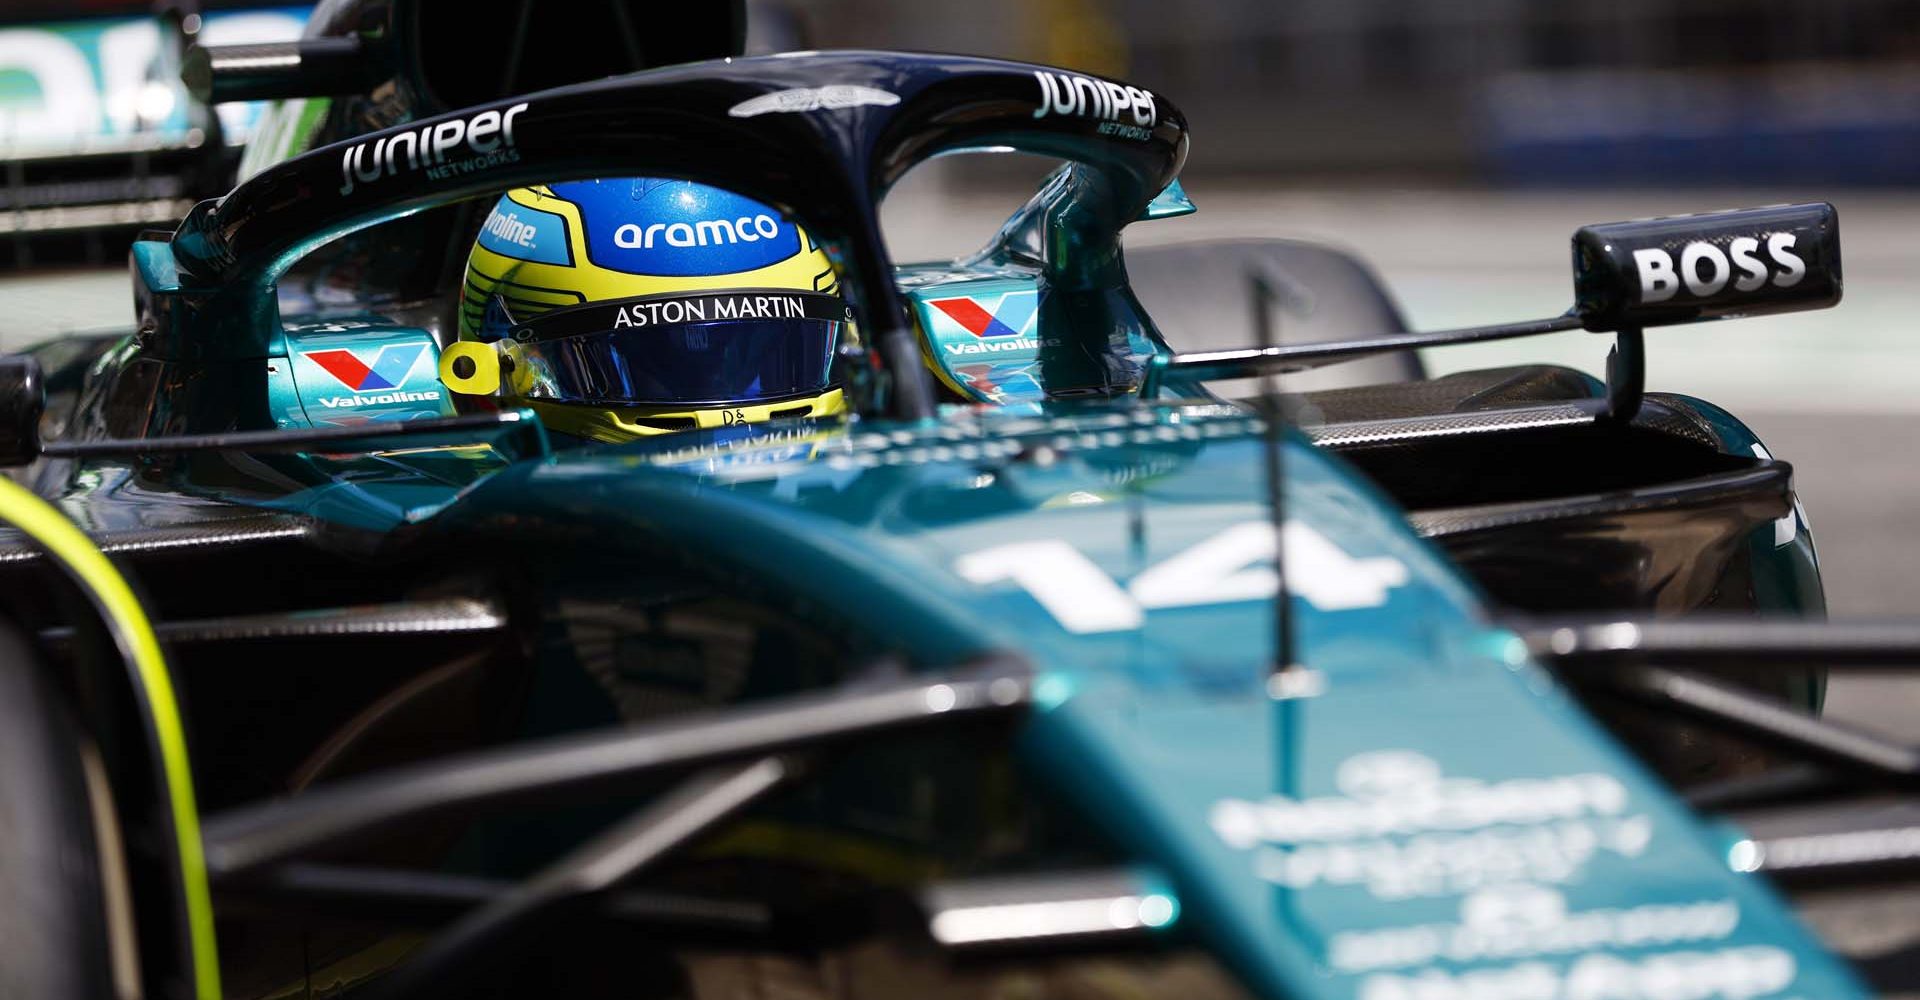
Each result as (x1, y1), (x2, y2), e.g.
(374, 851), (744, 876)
(0, 626), (113, 1000)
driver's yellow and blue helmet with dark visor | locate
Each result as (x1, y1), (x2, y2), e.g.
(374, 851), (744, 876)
(440, 177), (851, 441)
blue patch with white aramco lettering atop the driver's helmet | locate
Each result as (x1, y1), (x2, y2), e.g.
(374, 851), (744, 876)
(553, 179), (801, 276)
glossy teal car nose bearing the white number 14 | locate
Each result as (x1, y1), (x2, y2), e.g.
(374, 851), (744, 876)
(93, 391), (1864, 1000)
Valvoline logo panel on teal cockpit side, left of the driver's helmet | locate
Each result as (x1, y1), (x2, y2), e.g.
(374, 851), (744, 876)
(286, 321), (453, 424)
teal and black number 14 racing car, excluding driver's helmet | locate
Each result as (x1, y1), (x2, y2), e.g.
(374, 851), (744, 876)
(0, 11), (1920, 1000)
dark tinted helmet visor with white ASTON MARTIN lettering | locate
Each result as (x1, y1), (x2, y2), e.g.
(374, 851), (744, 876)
(507, 288), (847, 405)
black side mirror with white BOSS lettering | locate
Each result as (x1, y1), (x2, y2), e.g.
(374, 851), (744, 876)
(1572, 202), (1841, 330)
